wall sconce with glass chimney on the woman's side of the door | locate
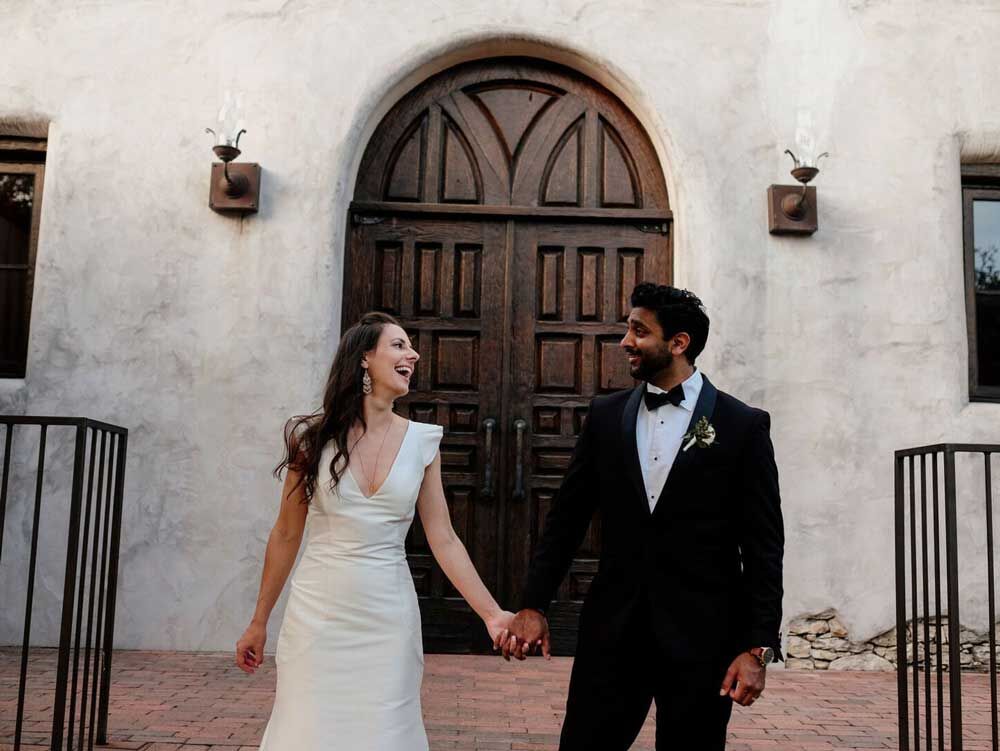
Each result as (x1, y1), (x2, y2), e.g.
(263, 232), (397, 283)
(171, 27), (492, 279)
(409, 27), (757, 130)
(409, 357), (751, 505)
(205, 92), (260, 214)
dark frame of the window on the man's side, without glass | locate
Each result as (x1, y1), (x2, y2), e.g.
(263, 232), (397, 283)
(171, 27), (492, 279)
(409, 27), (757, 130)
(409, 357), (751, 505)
(962, 164), (1000, 402)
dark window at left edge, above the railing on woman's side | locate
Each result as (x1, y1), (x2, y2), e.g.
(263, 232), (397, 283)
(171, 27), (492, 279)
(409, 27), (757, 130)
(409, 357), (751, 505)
(0, 139), (45, 378)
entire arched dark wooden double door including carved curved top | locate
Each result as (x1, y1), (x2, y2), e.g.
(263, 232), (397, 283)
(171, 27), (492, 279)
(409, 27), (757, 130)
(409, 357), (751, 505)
(343, 58), (672, 654)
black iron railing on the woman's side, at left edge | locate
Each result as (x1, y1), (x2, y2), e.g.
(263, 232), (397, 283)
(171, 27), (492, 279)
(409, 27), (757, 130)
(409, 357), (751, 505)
(0, 415), (128, 751)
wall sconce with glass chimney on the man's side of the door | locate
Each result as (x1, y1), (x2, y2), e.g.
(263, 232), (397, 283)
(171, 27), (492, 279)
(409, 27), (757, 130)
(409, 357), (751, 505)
(767, 112), (830, 235)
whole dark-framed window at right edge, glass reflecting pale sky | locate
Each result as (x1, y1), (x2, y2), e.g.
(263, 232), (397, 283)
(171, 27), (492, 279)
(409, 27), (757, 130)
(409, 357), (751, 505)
(962, 164), (1000, 401)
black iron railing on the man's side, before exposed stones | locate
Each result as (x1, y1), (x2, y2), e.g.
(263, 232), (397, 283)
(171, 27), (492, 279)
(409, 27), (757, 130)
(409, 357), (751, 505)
(895, 443), (1000, 751)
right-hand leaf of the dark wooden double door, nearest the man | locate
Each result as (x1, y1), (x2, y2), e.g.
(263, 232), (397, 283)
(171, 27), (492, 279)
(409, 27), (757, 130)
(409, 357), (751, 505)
(504, 222), (672, 654)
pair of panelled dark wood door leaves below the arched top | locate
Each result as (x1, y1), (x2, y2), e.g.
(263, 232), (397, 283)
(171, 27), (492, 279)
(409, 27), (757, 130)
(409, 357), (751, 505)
(344, 217), (671, 654)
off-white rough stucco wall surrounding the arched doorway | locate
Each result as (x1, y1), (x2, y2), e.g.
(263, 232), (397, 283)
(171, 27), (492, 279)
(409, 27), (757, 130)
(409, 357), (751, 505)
(0, 0), (1000, 649)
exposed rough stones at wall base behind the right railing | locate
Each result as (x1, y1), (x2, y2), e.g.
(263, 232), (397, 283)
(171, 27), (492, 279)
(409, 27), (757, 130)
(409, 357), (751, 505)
(785, 609), (990, 672)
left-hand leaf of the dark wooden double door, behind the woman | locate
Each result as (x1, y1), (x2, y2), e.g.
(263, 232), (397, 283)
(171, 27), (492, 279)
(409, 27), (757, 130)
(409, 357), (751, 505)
(344, 215), (507, 652)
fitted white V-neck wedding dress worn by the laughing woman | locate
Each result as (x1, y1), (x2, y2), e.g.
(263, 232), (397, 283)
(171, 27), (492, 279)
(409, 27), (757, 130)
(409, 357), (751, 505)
(260, 421), (443, 751)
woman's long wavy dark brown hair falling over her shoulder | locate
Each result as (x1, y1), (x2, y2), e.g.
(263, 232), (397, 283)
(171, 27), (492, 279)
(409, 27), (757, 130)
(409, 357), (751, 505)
(274, 312), (399, 503)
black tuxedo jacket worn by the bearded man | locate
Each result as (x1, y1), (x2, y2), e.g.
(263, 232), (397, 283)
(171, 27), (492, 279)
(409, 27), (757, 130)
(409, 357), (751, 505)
(522, 378), (784, 662)
